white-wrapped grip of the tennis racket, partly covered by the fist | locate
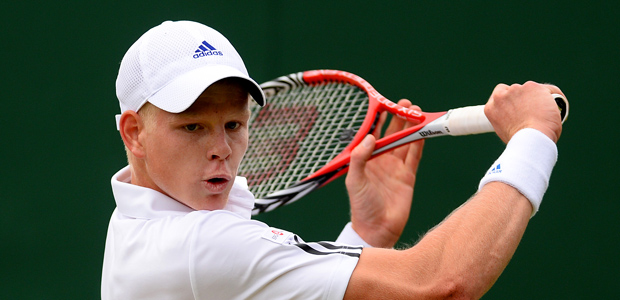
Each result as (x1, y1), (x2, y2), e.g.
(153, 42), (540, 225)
(445, 94), (568, 135)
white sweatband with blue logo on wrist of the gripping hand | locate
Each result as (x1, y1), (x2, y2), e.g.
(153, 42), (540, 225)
(478, 128), (558, 217)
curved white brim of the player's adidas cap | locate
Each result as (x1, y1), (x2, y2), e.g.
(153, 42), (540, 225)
(147, 65), (265, 113)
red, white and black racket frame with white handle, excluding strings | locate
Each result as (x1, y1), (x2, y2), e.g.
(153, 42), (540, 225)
(247, 69), (568, 215)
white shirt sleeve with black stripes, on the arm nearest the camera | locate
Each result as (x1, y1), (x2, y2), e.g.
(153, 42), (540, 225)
(189, 211), (362, 299)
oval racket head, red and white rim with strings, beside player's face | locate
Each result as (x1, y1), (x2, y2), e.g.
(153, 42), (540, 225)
(238, 70), (391, 214)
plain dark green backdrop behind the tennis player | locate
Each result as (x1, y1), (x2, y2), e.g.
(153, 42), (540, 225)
(0, 0), (620, 299)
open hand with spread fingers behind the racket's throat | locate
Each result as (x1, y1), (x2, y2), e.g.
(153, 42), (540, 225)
(345, 99), (424, 248)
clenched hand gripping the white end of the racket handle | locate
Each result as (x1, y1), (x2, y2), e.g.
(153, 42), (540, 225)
(484, 81), (564, 143)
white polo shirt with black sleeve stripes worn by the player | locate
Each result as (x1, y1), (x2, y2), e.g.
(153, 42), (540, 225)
(101, 167), (367, 299)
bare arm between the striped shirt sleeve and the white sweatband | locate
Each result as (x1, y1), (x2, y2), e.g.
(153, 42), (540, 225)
(346, 182), (532, 299)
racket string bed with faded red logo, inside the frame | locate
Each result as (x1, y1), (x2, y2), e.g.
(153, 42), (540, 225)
(239, 83), (368, 199)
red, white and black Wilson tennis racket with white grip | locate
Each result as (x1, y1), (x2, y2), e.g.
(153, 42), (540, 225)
(239, 70), (568, 215)
